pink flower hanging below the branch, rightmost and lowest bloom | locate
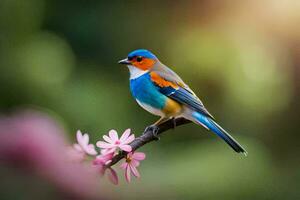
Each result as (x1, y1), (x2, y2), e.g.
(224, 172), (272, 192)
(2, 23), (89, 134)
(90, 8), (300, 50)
(120, 152), (146, 183)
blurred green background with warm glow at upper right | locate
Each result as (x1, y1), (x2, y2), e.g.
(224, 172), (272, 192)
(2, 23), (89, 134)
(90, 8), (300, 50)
(0, 0), (300, 200)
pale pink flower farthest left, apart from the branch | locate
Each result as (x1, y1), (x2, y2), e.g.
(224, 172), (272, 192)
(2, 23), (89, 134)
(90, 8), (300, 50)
(73, 130), (97, 156)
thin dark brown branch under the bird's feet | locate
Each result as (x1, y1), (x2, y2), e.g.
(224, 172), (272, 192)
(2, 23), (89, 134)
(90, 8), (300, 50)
(106, 118), (190, 167)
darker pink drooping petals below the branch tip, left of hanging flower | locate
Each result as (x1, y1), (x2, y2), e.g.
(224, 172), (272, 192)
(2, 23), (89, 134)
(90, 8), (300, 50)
(93, 152), (119, 185)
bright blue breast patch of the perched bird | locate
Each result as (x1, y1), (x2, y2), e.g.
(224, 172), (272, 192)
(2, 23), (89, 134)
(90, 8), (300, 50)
(130, 73), (167, 109)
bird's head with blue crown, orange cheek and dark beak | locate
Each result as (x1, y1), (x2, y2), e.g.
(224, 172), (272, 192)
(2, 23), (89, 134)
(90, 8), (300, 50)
(119, 49), (157, 70)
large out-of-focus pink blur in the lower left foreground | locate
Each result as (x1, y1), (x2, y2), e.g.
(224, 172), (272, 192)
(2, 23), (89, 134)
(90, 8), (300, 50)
(0, 110), (102, 199)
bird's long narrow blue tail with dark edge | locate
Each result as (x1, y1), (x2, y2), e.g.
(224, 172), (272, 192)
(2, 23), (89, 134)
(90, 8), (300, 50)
(192, 112), (247, 155)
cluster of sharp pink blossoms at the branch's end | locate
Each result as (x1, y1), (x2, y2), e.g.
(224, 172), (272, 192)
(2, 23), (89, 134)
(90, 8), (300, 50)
(73, 129), (145, 184)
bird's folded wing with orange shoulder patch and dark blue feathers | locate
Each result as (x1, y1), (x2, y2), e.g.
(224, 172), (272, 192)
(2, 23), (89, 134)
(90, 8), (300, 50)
(150, 67), (213, 119)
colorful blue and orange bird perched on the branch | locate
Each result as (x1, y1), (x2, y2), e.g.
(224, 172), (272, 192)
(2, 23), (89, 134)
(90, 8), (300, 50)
(119, 49), (247, 154)
